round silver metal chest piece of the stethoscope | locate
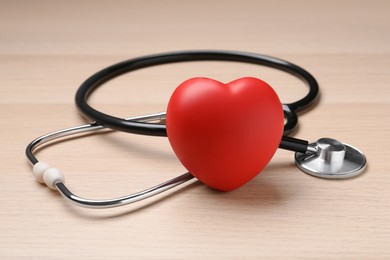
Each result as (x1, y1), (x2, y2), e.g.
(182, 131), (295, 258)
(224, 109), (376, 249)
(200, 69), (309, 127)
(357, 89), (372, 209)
(295, 138), (367, 179)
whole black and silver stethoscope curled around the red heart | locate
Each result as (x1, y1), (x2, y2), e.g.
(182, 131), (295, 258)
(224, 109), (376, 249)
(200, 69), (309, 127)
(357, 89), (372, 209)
(26, 51), (366, 208)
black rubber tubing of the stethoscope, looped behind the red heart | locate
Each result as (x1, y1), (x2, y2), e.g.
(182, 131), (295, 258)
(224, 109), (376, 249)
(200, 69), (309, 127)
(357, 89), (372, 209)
(76, 51), (319, 152)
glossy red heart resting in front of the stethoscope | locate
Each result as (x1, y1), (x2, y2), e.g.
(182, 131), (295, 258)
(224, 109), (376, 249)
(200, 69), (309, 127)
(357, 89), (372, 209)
(166, 77), (284, 191)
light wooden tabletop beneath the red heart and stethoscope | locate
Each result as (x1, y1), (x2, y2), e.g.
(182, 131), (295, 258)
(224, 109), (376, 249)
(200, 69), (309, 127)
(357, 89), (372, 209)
(0, 0), (390, 259)
